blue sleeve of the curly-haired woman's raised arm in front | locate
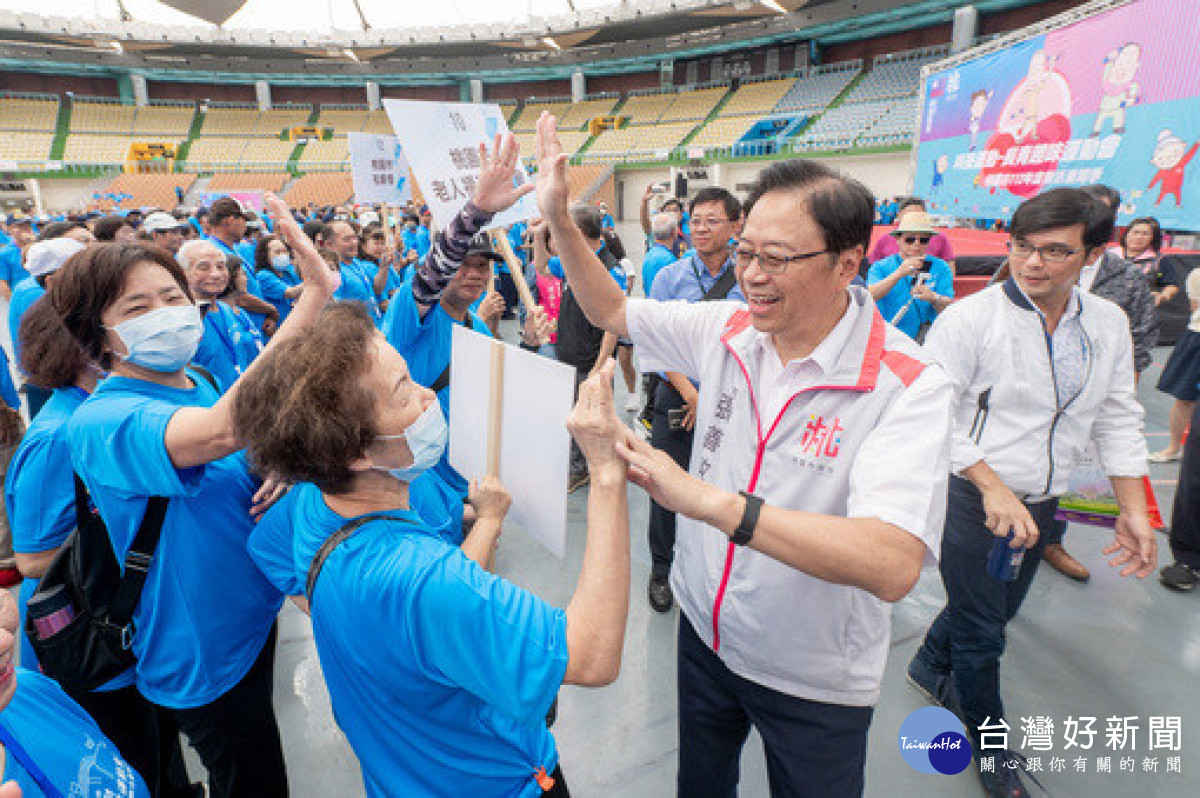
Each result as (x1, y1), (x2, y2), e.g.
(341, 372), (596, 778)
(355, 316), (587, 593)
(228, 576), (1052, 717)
(408, 546), (568, 722)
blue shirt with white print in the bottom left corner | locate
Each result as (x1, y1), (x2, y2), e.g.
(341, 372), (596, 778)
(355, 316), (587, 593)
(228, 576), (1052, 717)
(0, 667), (150, 798)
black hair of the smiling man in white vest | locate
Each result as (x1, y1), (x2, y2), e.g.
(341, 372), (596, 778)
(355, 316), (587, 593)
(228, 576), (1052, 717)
(743, 158), (875, 252)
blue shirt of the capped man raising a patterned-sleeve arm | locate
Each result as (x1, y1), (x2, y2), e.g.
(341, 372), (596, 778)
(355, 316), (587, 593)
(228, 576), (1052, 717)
(383, 286), (492, 498)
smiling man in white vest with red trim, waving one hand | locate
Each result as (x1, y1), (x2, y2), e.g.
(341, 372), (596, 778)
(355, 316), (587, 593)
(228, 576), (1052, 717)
(538, 115), (950, 798)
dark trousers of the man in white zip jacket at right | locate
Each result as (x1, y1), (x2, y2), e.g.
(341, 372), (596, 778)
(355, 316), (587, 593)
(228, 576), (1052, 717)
(917, 476), (1058, 734)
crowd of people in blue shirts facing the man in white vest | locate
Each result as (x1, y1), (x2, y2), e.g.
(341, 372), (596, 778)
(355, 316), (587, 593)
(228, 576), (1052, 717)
(0, 113), (1190, 798)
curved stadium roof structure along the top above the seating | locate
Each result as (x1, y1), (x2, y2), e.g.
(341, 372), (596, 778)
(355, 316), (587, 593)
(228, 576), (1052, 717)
(0, 0), (1039, 85)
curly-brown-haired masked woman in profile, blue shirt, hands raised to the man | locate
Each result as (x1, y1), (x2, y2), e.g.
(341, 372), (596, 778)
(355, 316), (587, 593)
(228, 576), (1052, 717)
(234, 302), (629, 797)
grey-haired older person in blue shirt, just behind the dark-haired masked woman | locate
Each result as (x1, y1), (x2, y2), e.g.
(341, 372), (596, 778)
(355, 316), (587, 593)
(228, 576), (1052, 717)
(175, 240), (264, 390)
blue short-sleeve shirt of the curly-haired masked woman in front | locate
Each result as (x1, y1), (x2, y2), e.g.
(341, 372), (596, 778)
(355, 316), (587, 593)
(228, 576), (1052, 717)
(293, 505), (568, 797)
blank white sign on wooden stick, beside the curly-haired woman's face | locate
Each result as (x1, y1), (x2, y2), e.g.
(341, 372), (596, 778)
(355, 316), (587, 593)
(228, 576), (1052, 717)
(450, 324), (575, 558)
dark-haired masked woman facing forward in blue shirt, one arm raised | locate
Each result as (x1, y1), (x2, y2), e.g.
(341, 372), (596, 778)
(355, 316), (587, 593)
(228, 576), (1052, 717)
(47, 197), (336, 797)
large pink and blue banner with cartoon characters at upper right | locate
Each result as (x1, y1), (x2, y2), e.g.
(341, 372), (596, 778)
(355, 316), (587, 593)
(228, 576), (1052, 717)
(913, 0), (1200, 230)
